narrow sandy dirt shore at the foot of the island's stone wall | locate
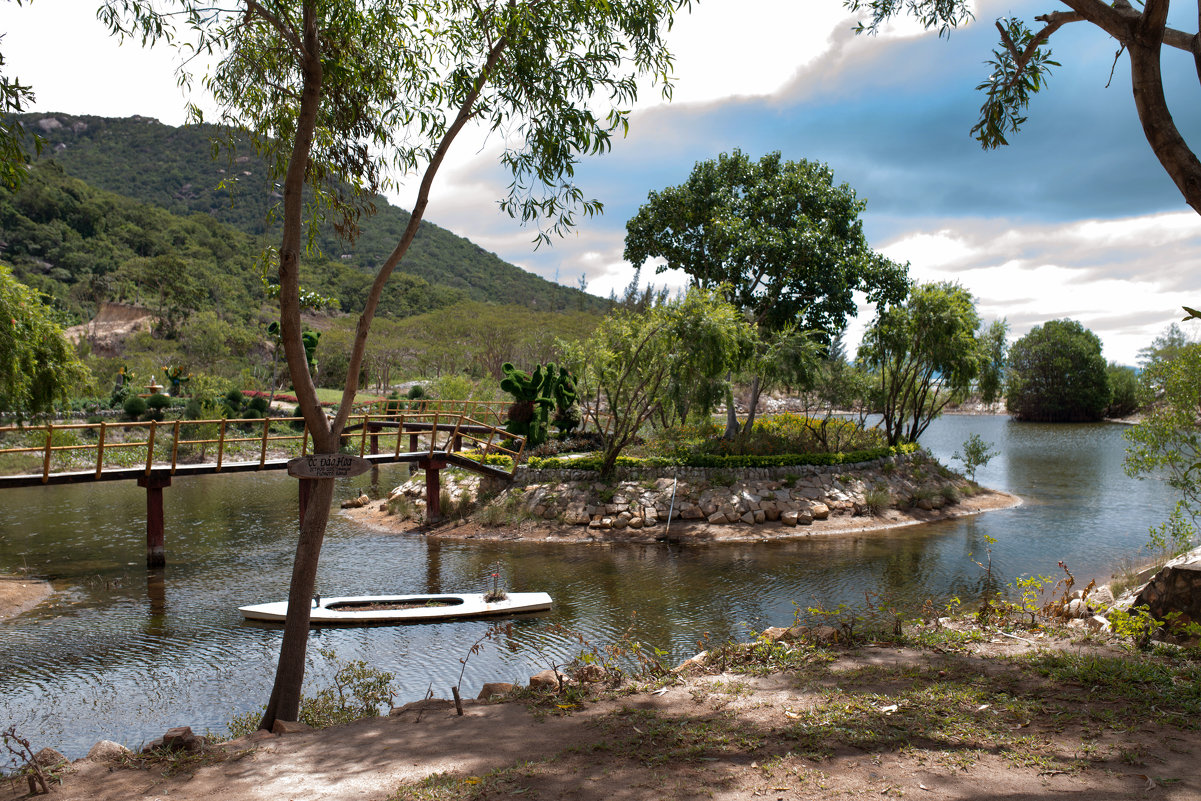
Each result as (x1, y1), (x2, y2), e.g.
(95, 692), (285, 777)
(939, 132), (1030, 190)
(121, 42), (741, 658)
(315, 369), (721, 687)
(342, 490), (1022, 544)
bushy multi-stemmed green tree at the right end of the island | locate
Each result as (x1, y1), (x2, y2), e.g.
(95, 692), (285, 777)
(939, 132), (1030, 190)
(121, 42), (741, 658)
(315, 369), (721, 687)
(859, 282), (985, 446)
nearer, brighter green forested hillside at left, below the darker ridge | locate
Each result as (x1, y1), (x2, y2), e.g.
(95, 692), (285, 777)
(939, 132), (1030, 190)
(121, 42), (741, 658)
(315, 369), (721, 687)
(0, 162), (464, 326)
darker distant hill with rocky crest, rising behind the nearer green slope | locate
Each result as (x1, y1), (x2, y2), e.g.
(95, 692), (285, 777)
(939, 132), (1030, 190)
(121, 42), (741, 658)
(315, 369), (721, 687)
(20, 113), (607, 311)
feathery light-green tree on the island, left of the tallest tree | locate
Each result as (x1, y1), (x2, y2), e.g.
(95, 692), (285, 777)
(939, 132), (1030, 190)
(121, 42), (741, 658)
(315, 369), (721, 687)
(564, 288), (753, 476)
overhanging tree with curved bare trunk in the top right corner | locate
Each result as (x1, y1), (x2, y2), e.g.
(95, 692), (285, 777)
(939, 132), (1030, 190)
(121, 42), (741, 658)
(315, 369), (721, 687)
(843, 0), (1201, 214)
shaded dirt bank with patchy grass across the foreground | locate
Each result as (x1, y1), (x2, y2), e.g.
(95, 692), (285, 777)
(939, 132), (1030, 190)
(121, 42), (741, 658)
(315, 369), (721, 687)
(0, 633), (1201, 801)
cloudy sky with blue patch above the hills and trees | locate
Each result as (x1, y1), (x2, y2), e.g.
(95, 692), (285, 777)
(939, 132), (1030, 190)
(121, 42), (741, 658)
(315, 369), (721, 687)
(0, 0), (1201, 365)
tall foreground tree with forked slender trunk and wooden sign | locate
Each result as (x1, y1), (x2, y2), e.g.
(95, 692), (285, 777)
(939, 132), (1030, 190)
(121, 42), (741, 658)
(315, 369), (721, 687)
(101, 0), (689, 728)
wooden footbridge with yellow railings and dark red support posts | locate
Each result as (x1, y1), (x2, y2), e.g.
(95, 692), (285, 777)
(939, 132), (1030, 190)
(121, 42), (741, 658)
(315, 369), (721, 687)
(0, 401), (525, 567)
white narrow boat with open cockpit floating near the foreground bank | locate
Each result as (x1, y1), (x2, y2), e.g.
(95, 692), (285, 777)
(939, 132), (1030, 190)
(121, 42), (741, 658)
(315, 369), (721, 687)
(238, 592), (551, 626)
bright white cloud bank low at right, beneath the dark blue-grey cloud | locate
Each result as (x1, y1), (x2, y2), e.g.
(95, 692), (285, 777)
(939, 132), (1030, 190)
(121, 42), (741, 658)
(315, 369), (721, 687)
(882, 211), (1201, 364)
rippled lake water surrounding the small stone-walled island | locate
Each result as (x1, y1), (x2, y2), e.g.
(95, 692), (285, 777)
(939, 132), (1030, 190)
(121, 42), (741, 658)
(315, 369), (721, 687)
(0, 416), (1173, 758)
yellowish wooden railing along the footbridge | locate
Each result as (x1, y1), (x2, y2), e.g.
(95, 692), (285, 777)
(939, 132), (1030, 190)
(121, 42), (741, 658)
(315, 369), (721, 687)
(0, 411), (525, 483)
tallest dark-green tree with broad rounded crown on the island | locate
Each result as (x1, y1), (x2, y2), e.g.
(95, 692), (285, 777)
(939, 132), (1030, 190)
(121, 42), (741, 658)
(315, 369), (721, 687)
(625, 150), (908, 435)
